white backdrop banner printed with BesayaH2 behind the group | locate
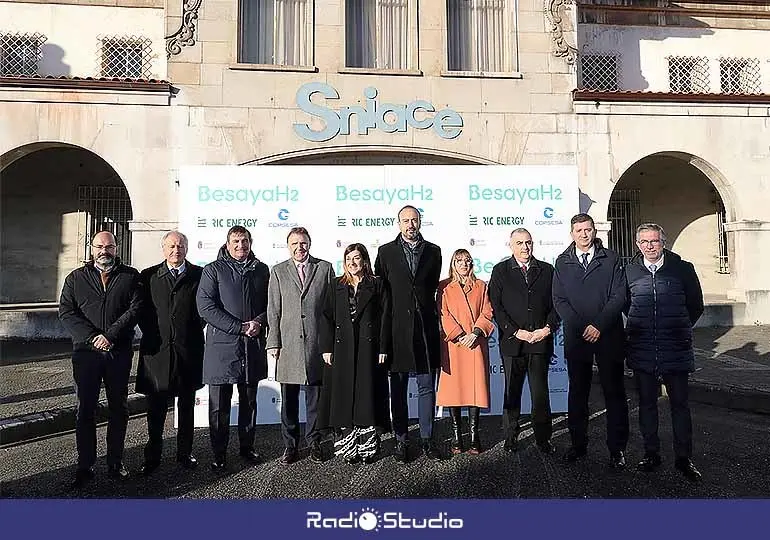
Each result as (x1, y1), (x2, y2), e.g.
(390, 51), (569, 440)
(179, 165), (578, 426)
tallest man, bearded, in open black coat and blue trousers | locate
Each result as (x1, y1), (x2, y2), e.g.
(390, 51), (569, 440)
(374, 206), (441, 462)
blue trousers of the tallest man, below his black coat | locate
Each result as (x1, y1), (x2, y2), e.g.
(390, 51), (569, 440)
(390, 370), (436, 442)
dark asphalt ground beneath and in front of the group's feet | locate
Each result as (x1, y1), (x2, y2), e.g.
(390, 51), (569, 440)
(0, 387), (770, 498)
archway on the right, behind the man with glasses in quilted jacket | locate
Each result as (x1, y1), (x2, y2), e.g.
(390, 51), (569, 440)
(607, 153), (733, 297)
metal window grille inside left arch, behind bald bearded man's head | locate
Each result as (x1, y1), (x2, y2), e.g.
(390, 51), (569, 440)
(78, 186), (133, 264)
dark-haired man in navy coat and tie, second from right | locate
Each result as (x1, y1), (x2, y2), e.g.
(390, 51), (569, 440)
(553, 214), (628, 469)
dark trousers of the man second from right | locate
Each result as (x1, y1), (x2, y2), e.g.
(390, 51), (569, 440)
(567, 343), (629, 452)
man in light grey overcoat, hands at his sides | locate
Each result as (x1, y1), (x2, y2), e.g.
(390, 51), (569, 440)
(267, 227), (335, 465)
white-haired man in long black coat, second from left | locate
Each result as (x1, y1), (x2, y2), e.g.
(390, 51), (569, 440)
(136, 231), (205, 475)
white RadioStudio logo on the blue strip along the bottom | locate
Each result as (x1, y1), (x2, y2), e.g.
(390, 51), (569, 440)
(305, 506), (465, 532)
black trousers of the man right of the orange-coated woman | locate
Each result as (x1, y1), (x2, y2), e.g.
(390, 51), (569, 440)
(503, 354), (553, 444)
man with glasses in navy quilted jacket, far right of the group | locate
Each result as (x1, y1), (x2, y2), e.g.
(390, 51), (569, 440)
(626, 223), (703, 481)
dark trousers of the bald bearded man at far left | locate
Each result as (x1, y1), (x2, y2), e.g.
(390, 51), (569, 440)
(72, 349), (133, 469)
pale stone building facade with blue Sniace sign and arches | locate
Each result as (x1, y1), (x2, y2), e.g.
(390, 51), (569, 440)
(0, 0), (770, 336)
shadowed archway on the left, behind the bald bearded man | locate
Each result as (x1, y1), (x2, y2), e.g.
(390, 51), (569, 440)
(0, 142), (133, 305)
